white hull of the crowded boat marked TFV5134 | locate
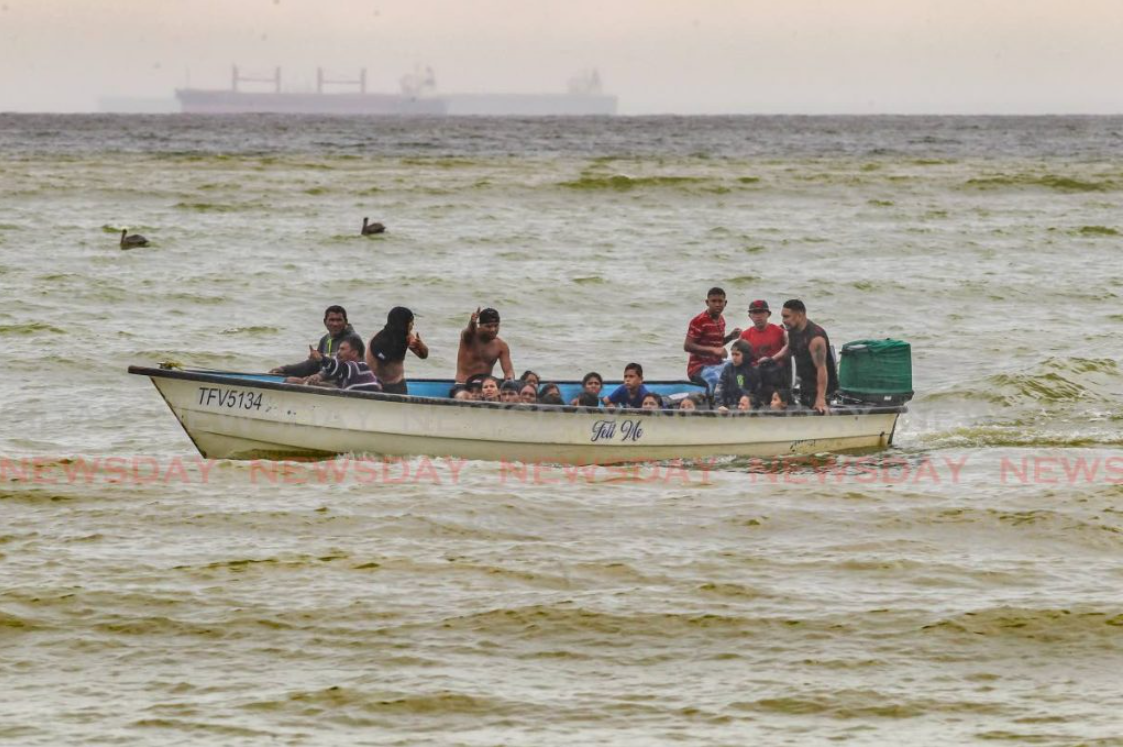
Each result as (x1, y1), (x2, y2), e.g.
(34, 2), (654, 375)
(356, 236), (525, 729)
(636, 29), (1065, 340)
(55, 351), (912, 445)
(129, 366), (905, 464)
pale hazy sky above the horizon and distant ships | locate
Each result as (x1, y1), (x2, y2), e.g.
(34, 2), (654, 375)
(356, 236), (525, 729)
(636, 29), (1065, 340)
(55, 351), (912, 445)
(0, 0), (1123, 113)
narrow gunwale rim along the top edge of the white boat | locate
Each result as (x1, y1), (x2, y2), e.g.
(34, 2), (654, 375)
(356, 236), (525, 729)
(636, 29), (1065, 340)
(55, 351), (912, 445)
(128, 365), (909, 418)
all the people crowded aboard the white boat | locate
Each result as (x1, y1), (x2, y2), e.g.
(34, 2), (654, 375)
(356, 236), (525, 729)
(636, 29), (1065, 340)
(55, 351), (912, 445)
(270, 288), (838, 412)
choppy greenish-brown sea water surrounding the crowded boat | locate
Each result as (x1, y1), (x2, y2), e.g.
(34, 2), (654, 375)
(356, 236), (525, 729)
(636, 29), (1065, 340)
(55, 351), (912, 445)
(0, 115), (1123, 745)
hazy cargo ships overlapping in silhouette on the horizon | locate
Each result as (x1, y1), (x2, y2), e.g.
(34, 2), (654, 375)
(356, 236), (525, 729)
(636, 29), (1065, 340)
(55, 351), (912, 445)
(175, 66), (617, 117)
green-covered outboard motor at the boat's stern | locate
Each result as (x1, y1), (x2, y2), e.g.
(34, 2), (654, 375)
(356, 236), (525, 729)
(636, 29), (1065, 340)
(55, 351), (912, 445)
(838, 339), (913, 404)
